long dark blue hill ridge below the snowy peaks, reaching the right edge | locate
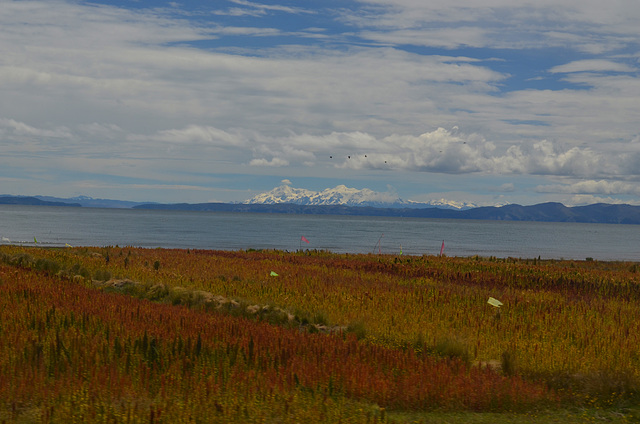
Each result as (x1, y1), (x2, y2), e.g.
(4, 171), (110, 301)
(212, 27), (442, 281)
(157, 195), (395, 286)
(135, 203), (640, 224)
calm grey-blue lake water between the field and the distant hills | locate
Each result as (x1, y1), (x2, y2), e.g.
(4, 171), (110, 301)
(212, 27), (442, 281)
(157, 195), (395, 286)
(0, 205), (640, 261)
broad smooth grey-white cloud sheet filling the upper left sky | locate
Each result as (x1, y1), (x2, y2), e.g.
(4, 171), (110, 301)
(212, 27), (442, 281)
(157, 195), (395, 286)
(0, 2), (504, 137)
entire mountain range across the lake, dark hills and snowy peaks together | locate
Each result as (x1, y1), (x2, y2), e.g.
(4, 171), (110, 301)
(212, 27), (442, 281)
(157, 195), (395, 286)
(0, 185), (640, 225)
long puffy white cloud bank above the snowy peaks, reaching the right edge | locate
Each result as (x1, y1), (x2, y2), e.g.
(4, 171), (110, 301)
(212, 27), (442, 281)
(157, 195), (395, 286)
(141, 126), (624, 181)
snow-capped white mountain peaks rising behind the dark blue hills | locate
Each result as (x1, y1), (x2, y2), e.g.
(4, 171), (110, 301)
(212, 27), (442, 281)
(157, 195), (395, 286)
(243, 184), (474, 210)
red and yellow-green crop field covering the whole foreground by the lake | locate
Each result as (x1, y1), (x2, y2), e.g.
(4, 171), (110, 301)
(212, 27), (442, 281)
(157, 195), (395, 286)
(0, 246), (640, 423)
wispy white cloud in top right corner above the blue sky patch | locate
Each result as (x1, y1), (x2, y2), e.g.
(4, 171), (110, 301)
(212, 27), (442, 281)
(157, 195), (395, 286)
(344, 0), (640, 53)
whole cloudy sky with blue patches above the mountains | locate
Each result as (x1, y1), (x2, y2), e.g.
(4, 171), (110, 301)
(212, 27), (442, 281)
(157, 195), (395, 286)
(0, 0), (640, 206)
